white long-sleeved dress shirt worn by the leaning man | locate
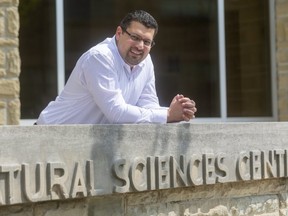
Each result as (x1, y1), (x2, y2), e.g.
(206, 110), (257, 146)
(37, 36), (167, 125)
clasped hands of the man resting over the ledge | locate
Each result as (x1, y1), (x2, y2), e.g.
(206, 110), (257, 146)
(167, 94), (197, 123)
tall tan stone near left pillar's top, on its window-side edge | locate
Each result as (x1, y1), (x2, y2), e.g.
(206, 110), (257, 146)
(7, 7), (19, 37)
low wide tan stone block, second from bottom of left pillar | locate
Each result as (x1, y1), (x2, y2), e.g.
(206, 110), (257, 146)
(0, 79), (20, 97)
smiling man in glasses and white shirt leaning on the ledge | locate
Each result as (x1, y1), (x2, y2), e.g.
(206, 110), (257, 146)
(37, 10), (196, 125)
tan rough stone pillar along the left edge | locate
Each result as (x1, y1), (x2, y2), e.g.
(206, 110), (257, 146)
(0, 0), (20, 125)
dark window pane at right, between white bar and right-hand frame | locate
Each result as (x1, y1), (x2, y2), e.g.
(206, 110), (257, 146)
(225, 0), (272, 117)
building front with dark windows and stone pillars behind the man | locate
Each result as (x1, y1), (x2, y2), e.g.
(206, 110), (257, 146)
(0, 0), (288, 125)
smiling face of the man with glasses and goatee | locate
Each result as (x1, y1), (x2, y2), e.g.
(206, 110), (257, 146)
(116, 21), (155, 66)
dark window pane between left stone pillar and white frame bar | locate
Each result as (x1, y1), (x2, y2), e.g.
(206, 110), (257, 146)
(19, 0), (57, 119)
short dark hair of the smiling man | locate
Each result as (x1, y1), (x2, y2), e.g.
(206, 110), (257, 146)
(120, 10), (158, 37)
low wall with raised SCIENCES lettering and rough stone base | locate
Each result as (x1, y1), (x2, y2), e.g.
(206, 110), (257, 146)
(0, 123), (288, 216)
